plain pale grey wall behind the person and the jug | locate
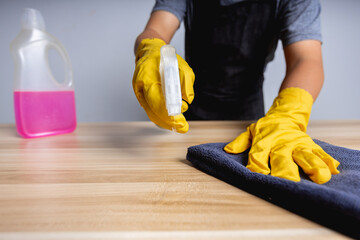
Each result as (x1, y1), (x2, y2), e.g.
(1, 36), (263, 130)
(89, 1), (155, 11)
(0, 0), (360, 123)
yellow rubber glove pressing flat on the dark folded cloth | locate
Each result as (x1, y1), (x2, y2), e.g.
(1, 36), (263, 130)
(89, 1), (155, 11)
(224, 88), (340, 184)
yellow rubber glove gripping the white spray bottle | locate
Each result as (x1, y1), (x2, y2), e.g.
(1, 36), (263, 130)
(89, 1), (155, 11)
(132, 38), (195, 133)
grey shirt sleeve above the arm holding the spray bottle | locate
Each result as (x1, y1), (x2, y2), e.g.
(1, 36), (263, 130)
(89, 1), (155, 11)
(152, 0), (186, 22)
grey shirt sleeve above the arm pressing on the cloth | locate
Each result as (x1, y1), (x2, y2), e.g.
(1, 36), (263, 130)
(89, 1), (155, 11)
(279, 0), (322, 47)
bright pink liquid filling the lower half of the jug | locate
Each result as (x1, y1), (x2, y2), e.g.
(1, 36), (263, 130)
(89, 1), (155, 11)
(14, 91), (76, 138)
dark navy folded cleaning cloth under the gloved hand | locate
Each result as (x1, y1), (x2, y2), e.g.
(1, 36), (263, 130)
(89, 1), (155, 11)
(186, 140), (360, 239)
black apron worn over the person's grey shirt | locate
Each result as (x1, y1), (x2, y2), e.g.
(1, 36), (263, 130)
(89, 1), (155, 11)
(184, 0), (279, 120)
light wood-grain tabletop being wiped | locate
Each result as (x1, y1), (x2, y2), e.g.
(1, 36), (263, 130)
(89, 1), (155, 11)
(0, 121), (360, 240)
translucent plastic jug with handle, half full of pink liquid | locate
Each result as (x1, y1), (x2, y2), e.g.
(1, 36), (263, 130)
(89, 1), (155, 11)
(10, 9), (76, 138)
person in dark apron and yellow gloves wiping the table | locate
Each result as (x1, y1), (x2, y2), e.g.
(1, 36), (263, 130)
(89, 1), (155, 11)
(133, 0), (339, 183)
